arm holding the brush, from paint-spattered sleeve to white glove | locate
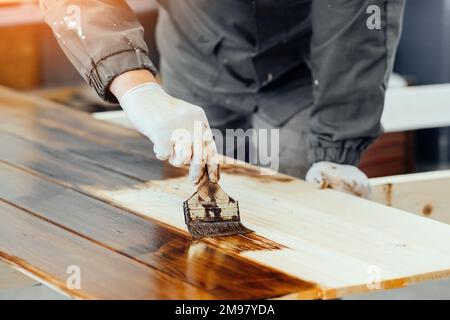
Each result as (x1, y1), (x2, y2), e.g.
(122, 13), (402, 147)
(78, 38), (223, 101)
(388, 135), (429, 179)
(40, 0), (219, 184)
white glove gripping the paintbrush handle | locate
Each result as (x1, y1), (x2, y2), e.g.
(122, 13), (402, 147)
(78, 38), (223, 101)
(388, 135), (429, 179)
(119, 82), (219, 184)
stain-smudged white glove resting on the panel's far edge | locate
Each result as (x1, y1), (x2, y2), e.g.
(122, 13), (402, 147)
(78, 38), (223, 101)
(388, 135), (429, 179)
(306, 161), (370, 198)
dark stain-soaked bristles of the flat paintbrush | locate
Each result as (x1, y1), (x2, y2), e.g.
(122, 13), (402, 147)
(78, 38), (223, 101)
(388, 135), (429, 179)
(188, 221), (252, 239)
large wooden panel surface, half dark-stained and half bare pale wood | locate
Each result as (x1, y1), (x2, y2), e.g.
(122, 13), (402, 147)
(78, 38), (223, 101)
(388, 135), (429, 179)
(0, 88), (450, 299)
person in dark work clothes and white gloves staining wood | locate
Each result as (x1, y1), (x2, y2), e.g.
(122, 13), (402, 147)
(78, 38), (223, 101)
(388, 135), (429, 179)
(41, 0), (404, 196)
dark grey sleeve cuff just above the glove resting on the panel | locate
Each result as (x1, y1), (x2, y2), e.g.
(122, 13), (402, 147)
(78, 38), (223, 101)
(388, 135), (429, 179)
(308, 147), (364, 166)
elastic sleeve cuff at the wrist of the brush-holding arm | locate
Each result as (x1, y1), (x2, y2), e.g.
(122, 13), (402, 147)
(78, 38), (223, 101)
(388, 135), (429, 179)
(87, 49), (157, 103)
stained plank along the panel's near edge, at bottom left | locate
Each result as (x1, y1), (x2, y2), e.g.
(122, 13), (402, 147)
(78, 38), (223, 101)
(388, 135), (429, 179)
(0, 202), (212, 299)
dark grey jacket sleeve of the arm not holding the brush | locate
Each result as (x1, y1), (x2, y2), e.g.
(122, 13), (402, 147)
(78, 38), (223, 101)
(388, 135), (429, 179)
(309, 0), (404, 165)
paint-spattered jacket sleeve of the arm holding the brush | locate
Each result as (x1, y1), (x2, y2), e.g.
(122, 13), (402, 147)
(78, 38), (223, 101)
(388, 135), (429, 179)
(39, 0), (156, 102)
